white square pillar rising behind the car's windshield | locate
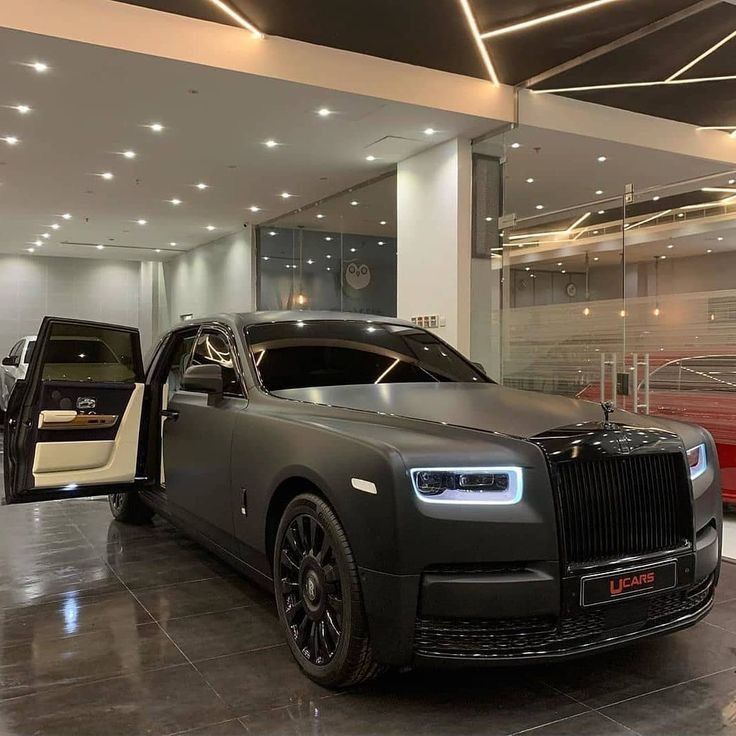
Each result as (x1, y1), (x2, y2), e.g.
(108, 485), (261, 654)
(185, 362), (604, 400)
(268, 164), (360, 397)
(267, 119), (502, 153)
(397, 138), (472, 354)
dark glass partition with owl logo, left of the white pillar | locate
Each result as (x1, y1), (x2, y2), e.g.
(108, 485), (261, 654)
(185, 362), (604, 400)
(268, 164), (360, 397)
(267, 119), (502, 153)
(256, 173), (396, 316)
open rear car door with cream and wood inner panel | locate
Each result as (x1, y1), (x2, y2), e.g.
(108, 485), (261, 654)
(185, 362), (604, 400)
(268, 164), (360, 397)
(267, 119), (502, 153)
(5, 317), (148, 503)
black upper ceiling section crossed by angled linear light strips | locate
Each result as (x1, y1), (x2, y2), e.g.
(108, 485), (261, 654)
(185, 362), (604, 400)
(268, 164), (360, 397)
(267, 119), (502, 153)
(118, 0), (736, 126)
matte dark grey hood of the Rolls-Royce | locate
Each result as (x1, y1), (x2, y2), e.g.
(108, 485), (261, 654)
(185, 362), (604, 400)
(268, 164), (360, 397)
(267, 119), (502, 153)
(272, 383), (648, 438)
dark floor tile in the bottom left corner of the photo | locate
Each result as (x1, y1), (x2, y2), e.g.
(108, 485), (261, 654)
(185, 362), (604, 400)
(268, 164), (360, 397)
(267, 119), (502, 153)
(0, 665), (233, 736)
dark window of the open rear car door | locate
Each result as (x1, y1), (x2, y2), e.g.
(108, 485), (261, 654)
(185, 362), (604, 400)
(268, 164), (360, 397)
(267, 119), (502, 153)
(40, 323), (143, 383)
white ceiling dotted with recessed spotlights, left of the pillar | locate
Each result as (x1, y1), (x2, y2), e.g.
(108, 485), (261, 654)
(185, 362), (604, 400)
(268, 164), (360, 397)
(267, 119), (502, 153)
(0, 29), (499, 259)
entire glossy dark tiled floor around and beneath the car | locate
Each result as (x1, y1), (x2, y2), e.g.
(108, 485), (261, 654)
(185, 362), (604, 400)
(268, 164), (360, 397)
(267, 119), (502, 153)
(0, 499), (736, 736)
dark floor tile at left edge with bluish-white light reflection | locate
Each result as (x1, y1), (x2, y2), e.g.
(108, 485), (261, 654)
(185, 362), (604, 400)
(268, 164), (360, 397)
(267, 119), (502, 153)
(0, 591), (152, 646)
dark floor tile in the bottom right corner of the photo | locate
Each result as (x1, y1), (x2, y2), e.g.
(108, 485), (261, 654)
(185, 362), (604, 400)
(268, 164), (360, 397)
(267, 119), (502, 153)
(602, 670), (736, 736)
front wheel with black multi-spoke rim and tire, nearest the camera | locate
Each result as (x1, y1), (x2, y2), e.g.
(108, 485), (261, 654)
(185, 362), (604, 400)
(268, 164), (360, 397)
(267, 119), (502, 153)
(273, 494), (383, 688)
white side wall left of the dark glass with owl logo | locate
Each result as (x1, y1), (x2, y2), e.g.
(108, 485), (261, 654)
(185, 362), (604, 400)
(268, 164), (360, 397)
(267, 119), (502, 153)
(160, 226), (255, 331)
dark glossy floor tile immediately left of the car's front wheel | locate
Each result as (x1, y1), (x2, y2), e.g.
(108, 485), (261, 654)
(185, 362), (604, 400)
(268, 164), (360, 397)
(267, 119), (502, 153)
(162, 606), (284, 662)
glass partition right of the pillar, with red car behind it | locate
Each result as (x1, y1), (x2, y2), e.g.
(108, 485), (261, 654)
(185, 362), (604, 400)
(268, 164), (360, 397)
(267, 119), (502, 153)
(472, 129), (736, 500)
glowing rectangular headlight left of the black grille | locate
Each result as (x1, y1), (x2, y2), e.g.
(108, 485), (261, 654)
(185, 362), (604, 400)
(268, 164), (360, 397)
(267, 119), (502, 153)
(411, 467), (523, 506)
